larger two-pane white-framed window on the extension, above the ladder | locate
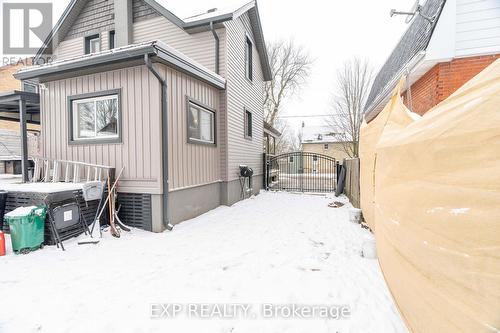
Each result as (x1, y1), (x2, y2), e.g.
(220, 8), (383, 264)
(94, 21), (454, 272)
(70, 93), (120, 142)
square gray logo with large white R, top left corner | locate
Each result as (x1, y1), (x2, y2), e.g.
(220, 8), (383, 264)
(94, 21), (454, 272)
(2, 3), (52, 55)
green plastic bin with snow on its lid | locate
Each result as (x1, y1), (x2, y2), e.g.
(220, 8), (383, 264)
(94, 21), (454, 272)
(5, 206), (47, 253)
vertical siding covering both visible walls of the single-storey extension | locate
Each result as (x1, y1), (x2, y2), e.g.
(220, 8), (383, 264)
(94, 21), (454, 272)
(41, 64), (220, 194)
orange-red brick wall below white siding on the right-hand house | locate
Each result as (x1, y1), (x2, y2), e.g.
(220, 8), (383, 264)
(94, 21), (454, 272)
(403, 54), (500, 115)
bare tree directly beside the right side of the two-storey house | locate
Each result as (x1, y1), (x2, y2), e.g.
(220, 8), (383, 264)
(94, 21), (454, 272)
(264, 40), (312, 126)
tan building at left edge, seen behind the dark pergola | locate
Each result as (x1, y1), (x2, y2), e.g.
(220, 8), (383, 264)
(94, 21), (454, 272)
(0, 59), (40, 175)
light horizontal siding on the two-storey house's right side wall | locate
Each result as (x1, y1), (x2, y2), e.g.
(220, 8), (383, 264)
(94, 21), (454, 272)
(226, 14), (264, 180)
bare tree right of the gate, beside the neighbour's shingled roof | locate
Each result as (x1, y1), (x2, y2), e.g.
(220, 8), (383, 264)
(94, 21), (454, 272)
(327, 58), (372, 157)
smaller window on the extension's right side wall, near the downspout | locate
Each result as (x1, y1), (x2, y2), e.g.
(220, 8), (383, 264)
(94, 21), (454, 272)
(188, 101), (215, 144)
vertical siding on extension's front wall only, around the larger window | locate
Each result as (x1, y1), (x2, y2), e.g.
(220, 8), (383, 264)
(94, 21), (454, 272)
(41, 66), (161, 193)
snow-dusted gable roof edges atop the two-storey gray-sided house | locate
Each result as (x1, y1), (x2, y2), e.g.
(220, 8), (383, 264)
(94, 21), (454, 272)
(35, 0), (272, 81)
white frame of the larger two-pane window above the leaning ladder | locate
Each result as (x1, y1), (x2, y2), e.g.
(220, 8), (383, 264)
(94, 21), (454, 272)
(71, 94), (121, 142)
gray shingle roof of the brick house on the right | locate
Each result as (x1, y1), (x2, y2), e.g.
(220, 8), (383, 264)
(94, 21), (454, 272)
(365, 0), (446, 112)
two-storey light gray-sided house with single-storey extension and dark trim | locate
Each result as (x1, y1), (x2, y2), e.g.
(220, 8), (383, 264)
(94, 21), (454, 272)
(16, 0), (271, 231)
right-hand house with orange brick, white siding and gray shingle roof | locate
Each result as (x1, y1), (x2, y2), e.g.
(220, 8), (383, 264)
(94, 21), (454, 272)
(365, 0), (500, 121)
